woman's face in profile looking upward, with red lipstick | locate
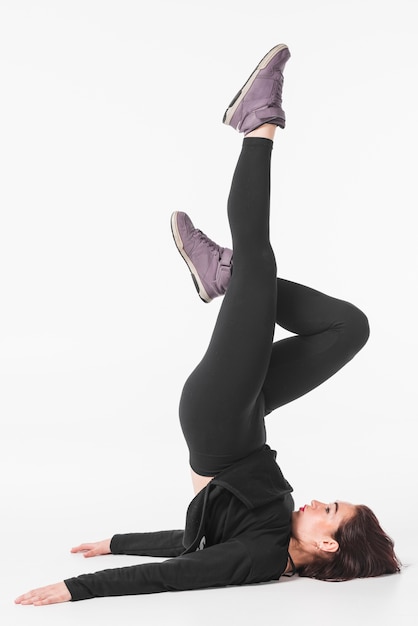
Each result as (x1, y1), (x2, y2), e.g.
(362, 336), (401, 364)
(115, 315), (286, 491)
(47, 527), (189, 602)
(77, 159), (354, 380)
(292, 500), (356, 551)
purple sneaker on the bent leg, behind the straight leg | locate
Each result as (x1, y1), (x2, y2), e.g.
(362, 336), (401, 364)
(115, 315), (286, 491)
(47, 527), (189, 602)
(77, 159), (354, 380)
(171, 211), (232, 302)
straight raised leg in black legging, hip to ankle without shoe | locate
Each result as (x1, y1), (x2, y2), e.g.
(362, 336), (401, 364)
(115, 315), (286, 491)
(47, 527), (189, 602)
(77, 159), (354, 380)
(176, 132), (276, 476)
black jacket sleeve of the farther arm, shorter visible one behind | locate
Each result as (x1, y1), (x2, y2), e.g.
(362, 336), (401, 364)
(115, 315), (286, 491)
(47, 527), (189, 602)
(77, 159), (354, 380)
(110, 530), (184, 556)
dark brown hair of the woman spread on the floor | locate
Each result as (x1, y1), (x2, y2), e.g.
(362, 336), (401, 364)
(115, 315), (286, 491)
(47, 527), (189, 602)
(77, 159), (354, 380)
(298, 504), (401, 581)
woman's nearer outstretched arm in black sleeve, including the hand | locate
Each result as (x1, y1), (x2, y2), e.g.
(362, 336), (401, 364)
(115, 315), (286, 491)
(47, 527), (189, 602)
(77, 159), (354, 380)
(16, 532), (287, 606)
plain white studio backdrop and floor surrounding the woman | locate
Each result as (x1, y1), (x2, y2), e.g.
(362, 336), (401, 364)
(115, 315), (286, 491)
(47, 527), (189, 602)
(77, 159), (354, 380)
(0, 0), (418, 626)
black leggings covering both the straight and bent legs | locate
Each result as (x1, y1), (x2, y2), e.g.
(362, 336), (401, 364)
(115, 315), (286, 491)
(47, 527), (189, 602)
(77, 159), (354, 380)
(180, 137), (369, 476)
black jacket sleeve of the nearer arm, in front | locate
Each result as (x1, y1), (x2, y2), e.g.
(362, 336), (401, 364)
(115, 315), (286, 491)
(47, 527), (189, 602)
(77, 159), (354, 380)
(64, 540), (251, 600)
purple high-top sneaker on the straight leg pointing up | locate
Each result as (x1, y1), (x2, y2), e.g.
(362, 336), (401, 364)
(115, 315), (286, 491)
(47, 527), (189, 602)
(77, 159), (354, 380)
(223, 44), (290, 135)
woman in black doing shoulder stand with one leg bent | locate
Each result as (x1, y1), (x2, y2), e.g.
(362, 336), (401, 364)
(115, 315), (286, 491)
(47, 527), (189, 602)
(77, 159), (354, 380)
(16, 45), (400, 605)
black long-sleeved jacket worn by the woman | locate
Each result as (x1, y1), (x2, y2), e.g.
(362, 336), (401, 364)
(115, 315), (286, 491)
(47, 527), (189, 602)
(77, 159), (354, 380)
(65, 445), (294, 600)
